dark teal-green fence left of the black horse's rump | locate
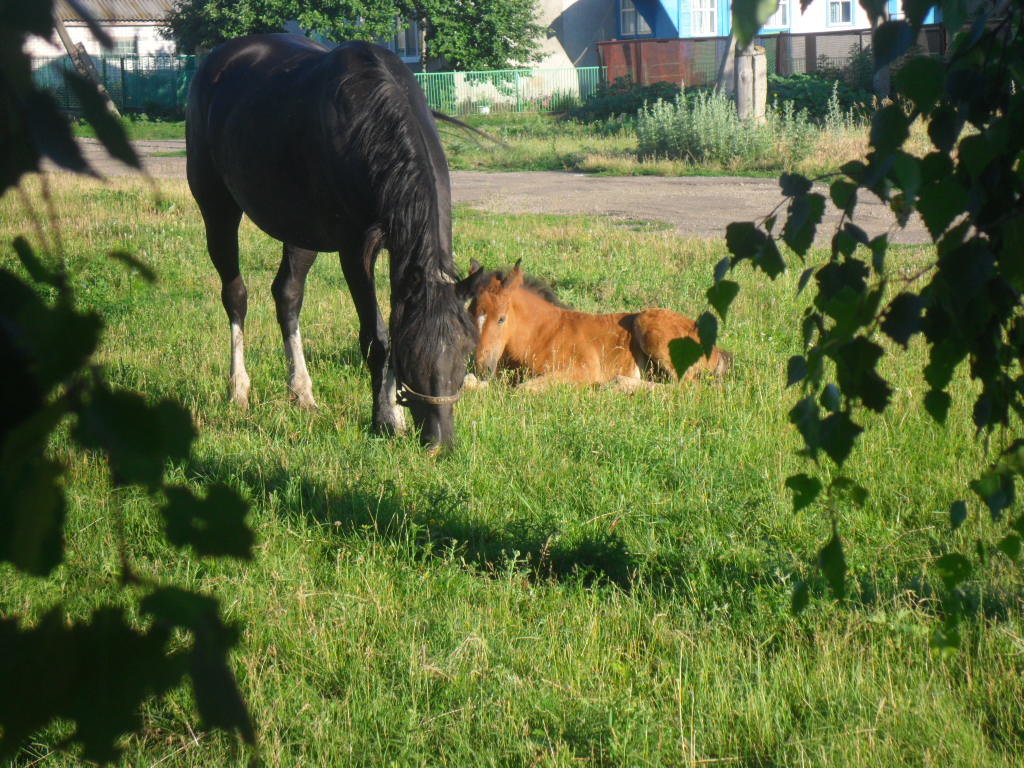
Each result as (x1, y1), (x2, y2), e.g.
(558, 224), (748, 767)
(32, 56), (197, 117)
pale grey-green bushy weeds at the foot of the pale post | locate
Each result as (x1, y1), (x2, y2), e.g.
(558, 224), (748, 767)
(636, 91), (814, 168)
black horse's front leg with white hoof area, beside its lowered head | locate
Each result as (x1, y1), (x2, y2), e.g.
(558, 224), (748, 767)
(341, 243), (406, 434)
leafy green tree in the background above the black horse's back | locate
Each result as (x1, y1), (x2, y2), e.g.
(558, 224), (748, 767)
(167, 0), (544, 70)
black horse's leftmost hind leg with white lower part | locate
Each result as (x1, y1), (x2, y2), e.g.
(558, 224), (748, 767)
(197, 204), (250, 409)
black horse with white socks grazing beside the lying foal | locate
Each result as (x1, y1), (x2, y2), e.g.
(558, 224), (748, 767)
(187, 35), (476, 445)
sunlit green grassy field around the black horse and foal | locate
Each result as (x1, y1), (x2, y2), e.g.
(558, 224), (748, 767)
(0, 177), (1024, 768)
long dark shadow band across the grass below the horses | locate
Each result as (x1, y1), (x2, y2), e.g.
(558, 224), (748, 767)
(186, 462), (1021, 623)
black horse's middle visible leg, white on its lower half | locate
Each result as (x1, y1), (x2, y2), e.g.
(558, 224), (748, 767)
(270, 243), (316, 408)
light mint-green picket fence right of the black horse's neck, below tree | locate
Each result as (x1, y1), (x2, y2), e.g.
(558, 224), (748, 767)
(416, 67), (604, 116)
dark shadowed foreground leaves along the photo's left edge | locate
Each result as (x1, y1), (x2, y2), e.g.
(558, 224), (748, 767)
(0, 2), (255, 762)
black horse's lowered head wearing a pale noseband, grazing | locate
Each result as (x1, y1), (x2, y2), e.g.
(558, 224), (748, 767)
(391, 268), (476, 447)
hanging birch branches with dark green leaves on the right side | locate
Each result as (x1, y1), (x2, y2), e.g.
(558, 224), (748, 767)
(709, 0), (1024, 648)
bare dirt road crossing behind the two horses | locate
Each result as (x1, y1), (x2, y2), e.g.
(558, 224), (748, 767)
(68, 139), (930, 244)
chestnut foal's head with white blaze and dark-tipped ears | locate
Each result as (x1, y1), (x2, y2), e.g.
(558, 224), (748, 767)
(460, 260), (523, 378)
